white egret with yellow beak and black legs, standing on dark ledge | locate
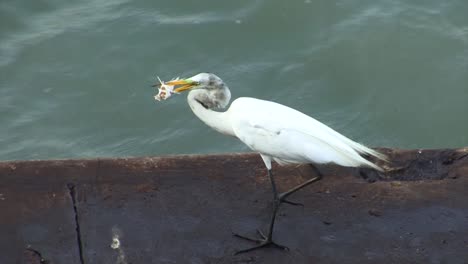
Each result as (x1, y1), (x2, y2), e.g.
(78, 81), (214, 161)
(159, 73), (386, 253)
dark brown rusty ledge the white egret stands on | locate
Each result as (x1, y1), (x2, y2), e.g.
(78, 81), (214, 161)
(0, 149), (468, 263)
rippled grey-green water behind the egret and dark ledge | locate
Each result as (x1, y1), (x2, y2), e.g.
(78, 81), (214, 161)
(0, 0), (468, 160)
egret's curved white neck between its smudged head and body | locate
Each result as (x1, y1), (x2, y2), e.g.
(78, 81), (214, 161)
(187, 89), (235, 136)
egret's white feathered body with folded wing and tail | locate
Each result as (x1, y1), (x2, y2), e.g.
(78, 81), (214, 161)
(229, 98), (383, 168)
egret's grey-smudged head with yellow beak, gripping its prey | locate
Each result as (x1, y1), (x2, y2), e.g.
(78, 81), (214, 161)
(160, 73), (231, 109)
